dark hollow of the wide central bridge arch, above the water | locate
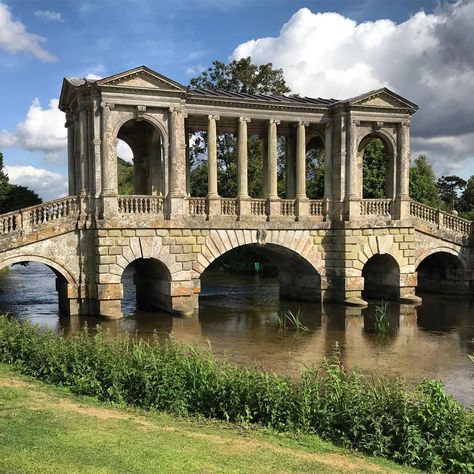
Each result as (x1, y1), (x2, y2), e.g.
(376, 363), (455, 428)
(201, 244), (321, 302)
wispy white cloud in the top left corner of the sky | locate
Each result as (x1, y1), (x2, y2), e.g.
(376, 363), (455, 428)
(0, 3), (57, 61)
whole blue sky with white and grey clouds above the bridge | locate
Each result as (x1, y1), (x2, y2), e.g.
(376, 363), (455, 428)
(0, 0), (474, 200)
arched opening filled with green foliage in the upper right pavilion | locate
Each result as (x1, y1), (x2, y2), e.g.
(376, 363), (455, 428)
(358, 135), (395, 199)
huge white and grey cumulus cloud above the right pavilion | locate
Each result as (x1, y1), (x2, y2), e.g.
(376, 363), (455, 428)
(232, 0), (474, 175)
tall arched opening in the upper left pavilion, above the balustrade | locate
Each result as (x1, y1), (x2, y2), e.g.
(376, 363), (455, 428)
(117, 120), (165, 195)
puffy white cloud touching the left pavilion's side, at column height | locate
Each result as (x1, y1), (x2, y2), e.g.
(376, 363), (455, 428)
(0, 99), (67, 157)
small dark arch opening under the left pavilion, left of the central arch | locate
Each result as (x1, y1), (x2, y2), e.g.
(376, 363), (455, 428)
(121, 258), (172, 314)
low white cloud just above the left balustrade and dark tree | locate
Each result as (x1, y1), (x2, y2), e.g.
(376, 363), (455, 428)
(5, 166), (68, 201)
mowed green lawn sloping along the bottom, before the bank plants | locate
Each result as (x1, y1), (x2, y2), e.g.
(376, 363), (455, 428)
(0, 364), (417, 474)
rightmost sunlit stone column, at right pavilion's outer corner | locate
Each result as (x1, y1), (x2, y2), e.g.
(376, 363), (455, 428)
(394, 122), (410, 219)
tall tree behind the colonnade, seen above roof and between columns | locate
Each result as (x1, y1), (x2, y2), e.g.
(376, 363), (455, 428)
(189, 57), (290, 197)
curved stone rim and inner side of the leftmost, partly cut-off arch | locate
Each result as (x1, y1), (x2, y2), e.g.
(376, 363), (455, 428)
(0, 255), (78, 315)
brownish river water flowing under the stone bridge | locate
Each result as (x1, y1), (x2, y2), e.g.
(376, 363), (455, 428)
(0, 263), (474, 405)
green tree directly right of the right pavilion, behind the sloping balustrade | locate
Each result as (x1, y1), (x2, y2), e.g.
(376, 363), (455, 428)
(410, 155), (441, 207)
